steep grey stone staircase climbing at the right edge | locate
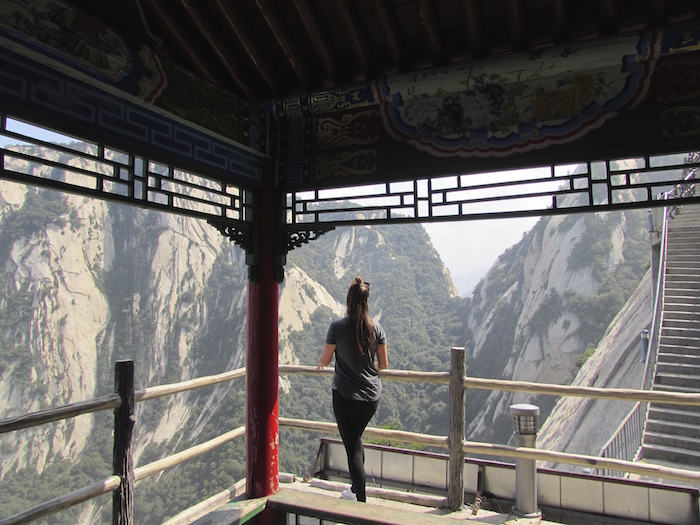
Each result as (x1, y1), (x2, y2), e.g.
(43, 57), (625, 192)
(640, 205), (700, 468)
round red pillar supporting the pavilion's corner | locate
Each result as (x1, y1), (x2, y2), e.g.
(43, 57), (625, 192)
(246, 159), (279, 498)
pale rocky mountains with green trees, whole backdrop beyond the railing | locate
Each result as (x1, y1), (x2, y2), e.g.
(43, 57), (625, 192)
(0, 146), (649, 525)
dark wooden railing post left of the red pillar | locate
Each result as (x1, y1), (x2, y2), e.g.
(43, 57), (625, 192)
(112, 361), (134, 525)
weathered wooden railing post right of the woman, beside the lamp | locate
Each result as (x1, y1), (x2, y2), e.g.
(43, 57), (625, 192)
(447, 347), (467, 511)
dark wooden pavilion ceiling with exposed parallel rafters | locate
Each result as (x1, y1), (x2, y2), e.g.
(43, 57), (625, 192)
(71, 0), (700, 101)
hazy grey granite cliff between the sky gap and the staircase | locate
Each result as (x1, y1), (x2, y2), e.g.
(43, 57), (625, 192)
(467, 203), (650, 441)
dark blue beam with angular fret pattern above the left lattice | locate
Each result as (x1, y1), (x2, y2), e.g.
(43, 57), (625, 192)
(0, 48), (262, 186)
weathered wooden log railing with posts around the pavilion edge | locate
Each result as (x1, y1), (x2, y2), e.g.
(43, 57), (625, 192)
(0, 347), (700, 525)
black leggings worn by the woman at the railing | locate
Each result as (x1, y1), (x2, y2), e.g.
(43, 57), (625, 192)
(333, 390), (379, 501)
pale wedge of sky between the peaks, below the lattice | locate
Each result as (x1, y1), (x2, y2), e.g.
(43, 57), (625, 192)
(423, 217), (539, 296)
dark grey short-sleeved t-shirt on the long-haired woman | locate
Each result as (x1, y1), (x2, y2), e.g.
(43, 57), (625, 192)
(326, 317), (386, 401)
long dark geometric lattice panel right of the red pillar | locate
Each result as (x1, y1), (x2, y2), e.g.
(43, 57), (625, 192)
(286, 150), (700, 226)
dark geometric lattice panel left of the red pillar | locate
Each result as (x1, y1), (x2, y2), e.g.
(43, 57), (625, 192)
(0, 115), (252, 223)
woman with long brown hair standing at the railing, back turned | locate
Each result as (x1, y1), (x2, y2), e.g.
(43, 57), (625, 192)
(316, 277), (389, 501)
